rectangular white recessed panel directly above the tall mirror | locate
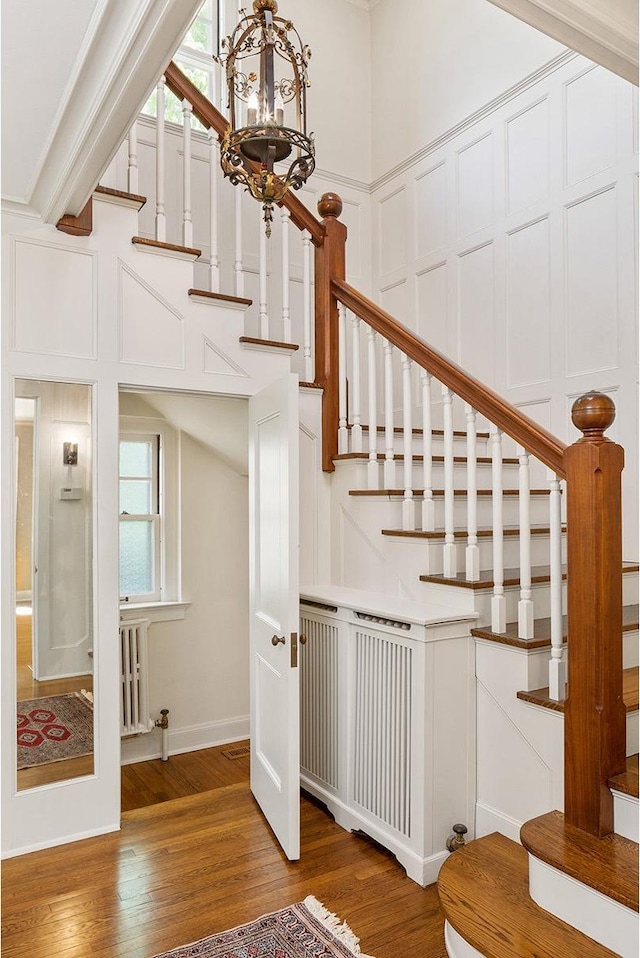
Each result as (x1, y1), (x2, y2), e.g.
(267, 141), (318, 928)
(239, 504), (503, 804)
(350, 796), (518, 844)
(12, 239), (97, 359)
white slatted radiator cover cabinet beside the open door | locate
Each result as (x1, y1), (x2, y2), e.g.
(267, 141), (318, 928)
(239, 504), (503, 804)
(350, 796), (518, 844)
(300, 587), (475, 885)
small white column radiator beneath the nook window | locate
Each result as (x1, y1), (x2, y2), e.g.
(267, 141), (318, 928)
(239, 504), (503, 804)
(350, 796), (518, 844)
(120, 619), (153, 736)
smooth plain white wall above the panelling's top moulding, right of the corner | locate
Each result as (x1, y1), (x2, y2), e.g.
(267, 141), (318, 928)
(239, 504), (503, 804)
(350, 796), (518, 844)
(371, 0), (563, 181)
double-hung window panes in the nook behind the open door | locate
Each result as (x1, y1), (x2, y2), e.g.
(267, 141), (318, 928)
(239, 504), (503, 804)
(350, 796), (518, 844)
(119, 435), (162, 602)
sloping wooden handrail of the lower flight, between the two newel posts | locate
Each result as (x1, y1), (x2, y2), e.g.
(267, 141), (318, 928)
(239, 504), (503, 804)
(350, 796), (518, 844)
(331, 280), (566, 478)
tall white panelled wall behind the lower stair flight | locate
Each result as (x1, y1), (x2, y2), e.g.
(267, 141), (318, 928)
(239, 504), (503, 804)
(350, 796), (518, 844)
(372, 54), (638, 559)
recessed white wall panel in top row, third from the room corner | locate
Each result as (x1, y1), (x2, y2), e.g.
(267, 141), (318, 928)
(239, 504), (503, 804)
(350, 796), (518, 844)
(457, 133), (494, 236)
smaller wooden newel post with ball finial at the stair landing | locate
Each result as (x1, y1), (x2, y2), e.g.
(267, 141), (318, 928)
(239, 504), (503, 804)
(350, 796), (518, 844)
(315, 193), (347, 472)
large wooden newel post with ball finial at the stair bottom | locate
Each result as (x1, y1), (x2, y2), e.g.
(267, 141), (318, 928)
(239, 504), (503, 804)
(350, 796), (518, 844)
(564, 392), (626, 836)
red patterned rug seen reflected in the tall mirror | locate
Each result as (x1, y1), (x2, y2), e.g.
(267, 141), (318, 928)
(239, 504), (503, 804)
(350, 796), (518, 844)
(18, 692), (93, 768)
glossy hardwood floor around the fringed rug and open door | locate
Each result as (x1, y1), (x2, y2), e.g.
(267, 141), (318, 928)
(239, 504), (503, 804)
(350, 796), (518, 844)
(2, 749), (446, 958)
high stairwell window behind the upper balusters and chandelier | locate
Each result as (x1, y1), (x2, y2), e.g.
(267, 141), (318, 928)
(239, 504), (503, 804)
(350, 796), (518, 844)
(142, 0), (218, 130)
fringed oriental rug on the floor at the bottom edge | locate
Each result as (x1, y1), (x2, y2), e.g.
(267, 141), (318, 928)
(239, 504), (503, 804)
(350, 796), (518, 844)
(151, 895), (371, 958)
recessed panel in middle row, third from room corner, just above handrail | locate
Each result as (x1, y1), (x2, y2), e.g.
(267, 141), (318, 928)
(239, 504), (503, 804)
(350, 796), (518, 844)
(458, 243), (495, 386)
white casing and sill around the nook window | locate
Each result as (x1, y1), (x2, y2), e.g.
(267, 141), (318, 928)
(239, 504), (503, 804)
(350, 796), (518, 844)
(118, 416), (181, 611)
